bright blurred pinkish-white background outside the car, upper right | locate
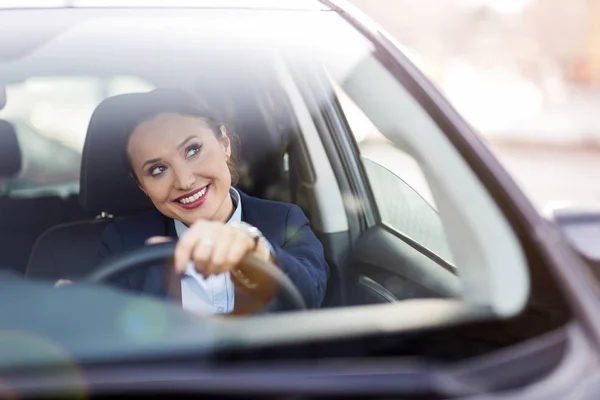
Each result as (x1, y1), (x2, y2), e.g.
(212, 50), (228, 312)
(350, 0), (600, 208)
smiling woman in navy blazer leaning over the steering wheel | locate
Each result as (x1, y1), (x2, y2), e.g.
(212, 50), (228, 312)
(99, 89), (329, 314)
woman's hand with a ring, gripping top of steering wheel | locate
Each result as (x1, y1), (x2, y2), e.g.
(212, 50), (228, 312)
(163, 221), (270, 277)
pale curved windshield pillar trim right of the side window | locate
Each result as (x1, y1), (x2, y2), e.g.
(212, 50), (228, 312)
(296, 14), (532, 317)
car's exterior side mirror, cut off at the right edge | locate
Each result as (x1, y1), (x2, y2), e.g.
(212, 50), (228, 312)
(546, 206), (600, 273)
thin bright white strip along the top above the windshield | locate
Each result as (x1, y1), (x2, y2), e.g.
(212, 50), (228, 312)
(0, 0), (330, 10)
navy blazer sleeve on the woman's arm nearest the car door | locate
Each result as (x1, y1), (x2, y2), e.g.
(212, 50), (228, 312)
(271, 205), (329, 308)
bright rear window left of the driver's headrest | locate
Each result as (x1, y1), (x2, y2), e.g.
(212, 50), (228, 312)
(0, 75), (154, 197)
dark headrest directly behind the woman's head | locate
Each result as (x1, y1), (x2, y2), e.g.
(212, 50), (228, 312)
(80, 93), (153, 216)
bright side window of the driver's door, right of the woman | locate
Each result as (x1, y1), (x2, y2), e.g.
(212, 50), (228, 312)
(336, 87), (453, 264)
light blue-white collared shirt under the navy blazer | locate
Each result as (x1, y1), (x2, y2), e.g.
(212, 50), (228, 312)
(175, 187), (242, 315)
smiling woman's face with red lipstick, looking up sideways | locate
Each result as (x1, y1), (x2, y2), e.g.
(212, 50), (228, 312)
(127, 113), (233, 225)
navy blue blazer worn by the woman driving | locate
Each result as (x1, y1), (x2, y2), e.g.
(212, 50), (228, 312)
(98, 190), (329, 308)
